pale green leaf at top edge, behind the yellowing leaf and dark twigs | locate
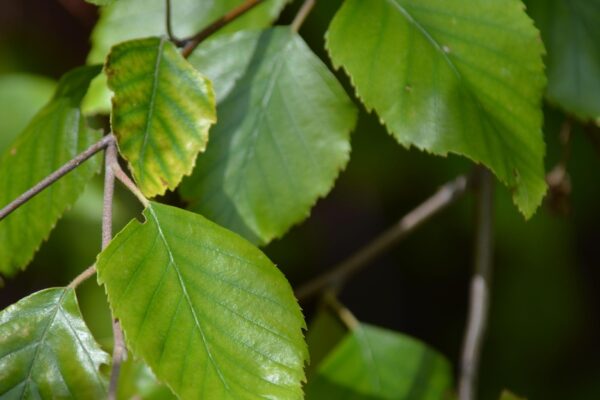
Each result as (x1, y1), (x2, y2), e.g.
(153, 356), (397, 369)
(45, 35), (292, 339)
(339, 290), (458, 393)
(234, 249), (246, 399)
(85, 0), (289, 112)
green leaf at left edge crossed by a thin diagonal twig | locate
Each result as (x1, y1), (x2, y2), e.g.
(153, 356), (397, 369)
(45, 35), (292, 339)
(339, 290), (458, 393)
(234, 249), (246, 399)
(0, 66), (100, 275)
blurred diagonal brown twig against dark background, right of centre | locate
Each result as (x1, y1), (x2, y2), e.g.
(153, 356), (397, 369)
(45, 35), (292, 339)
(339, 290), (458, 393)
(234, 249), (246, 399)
(296, 176), (469, 301)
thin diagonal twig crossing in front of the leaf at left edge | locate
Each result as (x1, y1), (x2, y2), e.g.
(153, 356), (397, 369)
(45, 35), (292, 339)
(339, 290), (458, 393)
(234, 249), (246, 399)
(0, 135), (115, 221)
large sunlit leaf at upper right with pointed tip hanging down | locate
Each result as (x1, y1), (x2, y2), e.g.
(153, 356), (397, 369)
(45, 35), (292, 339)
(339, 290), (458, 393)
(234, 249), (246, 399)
(326, 0), (546, 217)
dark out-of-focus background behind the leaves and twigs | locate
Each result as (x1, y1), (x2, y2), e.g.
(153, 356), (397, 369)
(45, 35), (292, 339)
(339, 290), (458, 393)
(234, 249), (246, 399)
(0, 0), (600, 400)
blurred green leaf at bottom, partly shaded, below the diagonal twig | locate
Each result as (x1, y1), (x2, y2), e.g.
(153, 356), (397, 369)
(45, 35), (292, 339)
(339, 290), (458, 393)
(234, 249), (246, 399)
(306, 324), (452, 400)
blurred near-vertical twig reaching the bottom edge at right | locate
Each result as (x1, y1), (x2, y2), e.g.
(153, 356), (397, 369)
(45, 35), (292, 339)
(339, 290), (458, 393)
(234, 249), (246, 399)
(458, 167), (494, 400)
